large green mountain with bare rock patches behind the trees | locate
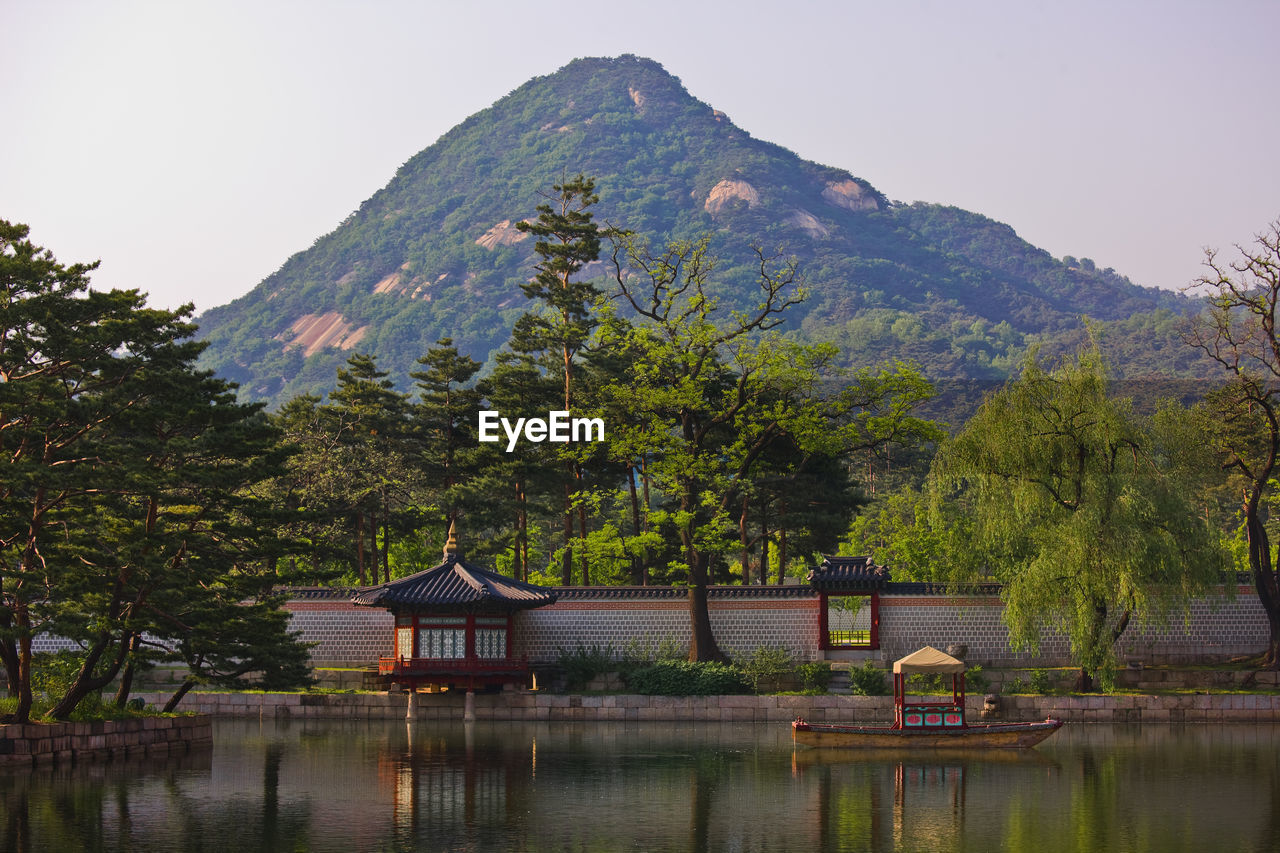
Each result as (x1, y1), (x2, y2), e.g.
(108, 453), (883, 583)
(198, 56), (1194, 403)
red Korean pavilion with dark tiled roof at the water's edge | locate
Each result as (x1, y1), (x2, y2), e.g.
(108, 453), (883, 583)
(352, 525), (556, 692)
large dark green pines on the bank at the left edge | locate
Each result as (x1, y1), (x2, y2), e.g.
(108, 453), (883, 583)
(0, 222), (309, 721)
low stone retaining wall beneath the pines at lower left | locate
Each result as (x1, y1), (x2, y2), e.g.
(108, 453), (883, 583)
(0, 716), (214, 766)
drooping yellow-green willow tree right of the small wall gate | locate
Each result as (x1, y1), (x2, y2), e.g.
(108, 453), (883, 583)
(931, 347), (1221, 690)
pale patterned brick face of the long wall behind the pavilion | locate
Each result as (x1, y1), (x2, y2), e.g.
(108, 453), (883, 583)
(33, 585), (1268, 667)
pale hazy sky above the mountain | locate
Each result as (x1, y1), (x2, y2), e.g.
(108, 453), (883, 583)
(0, 0), (1280, 309)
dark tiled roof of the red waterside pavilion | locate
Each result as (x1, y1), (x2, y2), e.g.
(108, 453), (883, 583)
(351, 553), (556, 611)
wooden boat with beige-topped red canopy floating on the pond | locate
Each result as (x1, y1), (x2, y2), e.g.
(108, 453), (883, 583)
(791, 646), (1062, 749)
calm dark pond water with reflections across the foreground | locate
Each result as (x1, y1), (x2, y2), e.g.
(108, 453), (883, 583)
(0, 721), (1280, 853)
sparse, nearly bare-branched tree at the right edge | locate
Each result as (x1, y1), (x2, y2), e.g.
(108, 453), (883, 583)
(1188, 220), (1280, 669)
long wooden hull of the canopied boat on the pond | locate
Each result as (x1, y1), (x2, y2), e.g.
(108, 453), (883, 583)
(791, 720), (1062, 749)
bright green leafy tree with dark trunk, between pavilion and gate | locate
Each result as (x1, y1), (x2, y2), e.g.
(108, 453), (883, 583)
(608, 238), (936, 661)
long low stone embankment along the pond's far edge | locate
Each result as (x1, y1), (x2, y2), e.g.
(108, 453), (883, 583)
(127, 692), (1280, 724)
